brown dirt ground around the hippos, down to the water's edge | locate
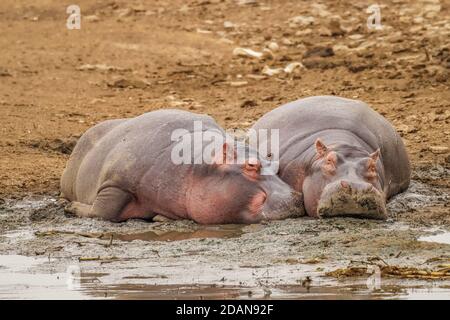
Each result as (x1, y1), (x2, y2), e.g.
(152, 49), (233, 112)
(0, 0), (450, 297)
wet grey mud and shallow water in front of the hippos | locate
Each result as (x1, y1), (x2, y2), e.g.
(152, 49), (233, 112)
(0, 167), (450, 299)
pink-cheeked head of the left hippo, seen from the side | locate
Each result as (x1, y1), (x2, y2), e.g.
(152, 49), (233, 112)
(188, 143), (304, 224)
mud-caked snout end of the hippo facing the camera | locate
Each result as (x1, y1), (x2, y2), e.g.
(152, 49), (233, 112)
(317, 180), (387, 220)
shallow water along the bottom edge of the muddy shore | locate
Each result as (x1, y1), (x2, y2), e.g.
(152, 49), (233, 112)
(0, 250), (450, 299)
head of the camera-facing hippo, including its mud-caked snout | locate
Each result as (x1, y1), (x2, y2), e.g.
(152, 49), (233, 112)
(303, 139), (386, 219)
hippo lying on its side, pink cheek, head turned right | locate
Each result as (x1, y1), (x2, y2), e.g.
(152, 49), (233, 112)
(61, 109), (303, 224)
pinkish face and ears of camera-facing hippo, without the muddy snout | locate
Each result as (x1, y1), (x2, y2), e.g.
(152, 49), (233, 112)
(303, 139), (384, 217)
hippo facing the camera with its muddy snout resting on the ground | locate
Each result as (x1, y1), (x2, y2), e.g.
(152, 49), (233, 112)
(253, 96), (411, 219)
